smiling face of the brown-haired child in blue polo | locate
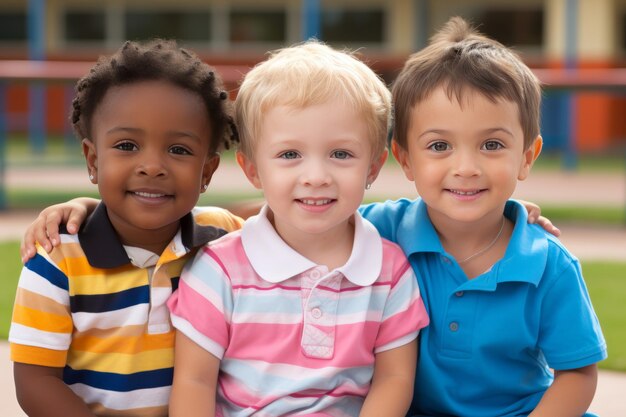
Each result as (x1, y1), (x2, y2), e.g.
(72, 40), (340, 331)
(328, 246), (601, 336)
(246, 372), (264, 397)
(393, 88), (541, 226)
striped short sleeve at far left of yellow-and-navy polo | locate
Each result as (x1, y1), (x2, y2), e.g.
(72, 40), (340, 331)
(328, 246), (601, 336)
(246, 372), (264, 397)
(9, 248), (73, 367)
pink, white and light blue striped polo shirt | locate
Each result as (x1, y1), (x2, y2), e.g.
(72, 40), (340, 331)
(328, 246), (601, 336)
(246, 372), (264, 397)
(168, 207), (428, 417)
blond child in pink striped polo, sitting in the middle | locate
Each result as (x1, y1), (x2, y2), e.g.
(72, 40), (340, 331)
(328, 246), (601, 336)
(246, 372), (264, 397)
(168, 42), (428, 417)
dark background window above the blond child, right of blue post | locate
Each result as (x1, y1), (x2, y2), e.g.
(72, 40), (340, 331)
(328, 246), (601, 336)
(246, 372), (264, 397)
(321, 9), (385, 43)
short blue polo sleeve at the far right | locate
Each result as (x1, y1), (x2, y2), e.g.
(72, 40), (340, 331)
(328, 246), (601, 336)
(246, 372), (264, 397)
(538, 255), (607, 370)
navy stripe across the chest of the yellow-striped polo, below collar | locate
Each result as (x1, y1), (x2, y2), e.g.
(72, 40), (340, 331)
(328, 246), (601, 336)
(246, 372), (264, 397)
(70, 285), (150, 313)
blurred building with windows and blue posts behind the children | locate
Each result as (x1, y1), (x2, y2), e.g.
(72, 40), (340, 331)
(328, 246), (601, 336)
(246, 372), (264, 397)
(0, 0), (626, 153)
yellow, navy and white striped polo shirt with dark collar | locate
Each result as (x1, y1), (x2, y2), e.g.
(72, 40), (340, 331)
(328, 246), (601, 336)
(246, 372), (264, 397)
(9, 204), (242, 417)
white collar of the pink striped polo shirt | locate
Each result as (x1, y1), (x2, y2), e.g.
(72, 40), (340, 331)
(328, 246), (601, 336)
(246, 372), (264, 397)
(241, 205), (383, 286)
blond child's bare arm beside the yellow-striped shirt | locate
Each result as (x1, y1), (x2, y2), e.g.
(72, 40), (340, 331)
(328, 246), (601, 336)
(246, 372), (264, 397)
(169, 330), (220, 417)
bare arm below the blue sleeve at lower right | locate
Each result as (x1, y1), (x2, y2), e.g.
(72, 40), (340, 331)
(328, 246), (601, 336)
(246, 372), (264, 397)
(528, 364), (598, 417)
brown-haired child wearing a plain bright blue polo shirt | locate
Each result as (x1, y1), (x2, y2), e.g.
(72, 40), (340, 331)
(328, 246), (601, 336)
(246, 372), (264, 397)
(362, 18), (606, 417)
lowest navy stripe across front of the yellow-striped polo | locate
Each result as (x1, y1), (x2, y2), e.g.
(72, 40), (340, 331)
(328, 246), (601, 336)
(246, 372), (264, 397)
(63, 366), (174, 392)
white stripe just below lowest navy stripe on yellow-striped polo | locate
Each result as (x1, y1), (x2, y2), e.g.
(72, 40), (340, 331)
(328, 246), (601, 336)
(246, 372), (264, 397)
(69, 384), (172, 410)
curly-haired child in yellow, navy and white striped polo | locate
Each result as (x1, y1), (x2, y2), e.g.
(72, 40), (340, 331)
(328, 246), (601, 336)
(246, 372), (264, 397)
(9, 41), (242, 417)
